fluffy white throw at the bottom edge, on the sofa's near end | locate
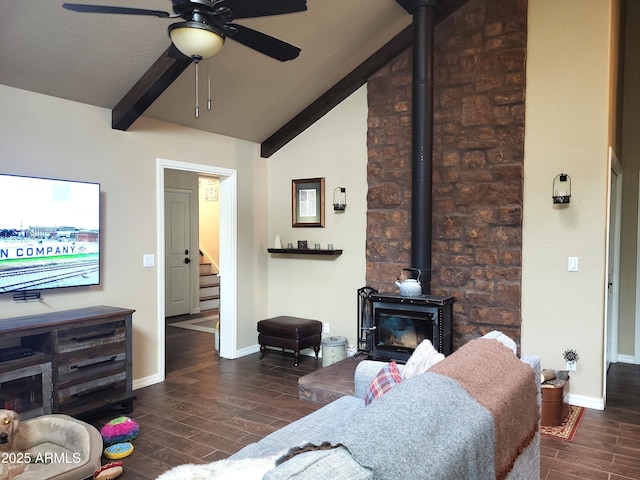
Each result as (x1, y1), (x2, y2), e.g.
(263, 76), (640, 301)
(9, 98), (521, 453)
(156, 455), (280, 480)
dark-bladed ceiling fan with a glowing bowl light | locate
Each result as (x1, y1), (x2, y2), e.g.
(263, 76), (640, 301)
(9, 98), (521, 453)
(62, 0), (307, 63)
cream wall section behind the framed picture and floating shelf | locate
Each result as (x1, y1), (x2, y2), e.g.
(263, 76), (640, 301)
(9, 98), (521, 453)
(265, 86), (368, 344)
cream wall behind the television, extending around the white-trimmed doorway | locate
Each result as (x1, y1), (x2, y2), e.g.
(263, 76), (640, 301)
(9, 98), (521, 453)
(0, 85), (267, 380)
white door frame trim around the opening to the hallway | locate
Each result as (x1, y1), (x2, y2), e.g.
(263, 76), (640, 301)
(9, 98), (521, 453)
(156, 159), (237, 381)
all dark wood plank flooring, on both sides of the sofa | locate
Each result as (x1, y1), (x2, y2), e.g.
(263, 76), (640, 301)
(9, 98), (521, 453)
(92, 316), (640, 480)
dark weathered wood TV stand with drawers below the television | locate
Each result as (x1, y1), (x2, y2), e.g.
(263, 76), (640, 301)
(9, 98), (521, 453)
(0, 306), (135, 419)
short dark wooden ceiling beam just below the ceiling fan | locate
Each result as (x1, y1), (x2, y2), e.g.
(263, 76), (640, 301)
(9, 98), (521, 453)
(111, 49), (192, 130)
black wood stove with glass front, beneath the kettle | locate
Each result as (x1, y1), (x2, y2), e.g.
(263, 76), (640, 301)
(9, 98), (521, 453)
(358, 293), (455, 363)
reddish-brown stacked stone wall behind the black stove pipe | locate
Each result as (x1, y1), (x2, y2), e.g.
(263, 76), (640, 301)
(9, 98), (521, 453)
(366, 0), (527, 348)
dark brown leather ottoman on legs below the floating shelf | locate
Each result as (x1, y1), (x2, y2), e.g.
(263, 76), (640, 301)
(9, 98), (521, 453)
(258, 316), (322, 367)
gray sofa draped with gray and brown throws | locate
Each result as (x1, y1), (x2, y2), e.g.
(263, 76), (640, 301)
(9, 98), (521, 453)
(159, 339), (540, 480)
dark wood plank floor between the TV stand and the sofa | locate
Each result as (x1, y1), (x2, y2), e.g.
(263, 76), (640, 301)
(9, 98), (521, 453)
(90, 316), (322, 480)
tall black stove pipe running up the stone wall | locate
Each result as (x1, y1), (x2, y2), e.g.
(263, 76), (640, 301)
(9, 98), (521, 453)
(411, 0), (436, 294)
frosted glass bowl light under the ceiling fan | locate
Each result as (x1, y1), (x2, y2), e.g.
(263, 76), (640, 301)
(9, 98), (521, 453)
(169, 21), (224, 61)
